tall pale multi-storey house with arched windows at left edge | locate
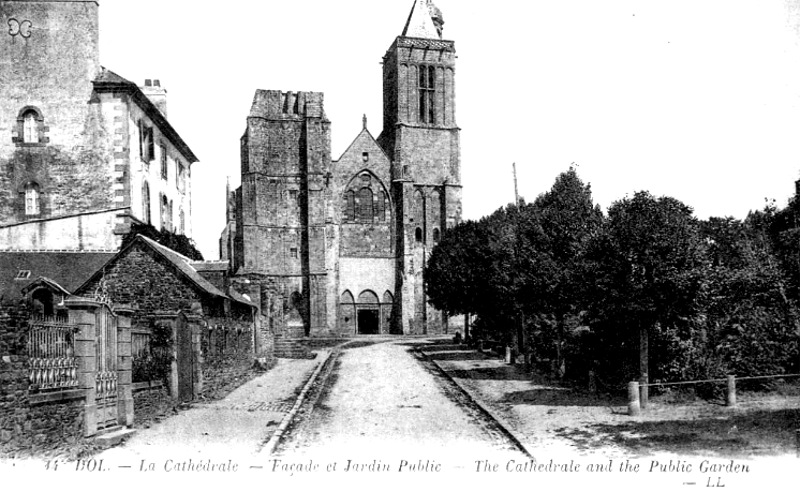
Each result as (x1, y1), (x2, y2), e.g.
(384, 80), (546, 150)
(0, 0), (197, 250)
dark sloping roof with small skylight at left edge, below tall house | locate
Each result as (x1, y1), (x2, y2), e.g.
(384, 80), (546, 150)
(0, 251), (116, 299)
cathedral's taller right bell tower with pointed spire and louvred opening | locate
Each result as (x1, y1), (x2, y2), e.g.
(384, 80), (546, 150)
(378, 0), (461, 334)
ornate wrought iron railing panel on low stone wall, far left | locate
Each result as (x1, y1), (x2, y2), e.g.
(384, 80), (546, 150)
(27, 317), (78, 392)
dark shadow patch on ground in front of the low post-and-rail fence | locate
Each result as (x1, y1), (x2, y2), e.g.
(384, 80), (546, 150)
(555, 409), (800, 458)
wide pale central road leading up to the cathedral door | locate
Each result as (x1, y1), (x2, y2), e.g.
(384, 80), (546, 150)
(278, 342), (522, 460)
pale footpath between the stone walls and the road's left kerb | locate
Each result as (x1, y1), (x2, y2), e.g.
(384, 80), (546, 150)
(98, 355), (322, 462)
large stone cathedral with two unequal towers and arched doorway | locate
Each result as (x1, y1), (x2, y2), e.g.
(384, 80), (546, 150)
(220, 0), (461, 337)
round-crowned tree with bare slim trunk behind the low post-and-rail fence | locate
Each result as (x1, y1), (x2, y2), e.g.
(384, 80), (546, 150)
(587, 192), (704, 398)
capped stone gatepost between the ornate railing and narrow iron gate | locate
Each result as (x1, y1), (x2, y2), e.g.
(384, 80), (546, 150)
(64, 298), (103, 437)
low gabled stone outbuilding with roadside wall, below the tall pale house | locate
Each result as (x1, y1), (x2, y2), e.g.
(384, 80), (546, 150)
(75, 235), (262, 401)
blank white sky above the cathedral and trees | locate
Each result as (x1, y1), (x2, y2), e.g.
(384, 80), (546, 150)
(100, 0), (800, 259)
